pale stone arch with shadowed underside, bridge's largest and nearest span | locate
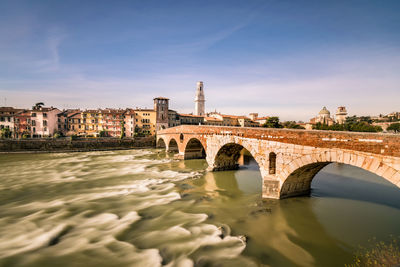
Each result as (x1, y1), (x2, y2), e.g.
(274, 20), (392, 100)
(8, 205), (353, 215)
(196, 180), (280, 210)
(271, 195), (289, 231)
(279, 151), (400, 198)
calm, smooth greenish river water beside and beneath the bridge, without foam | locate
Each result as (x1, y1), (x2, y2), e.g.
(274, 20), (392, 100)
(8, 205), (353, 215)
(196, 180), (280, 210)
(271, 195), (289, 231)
(177, 158), (400, 266)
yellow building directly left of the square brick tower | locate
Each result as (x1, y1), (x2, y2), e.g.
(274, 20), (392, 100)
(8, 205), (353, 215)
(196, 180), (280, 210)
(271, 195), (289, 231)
(135, 109), (157, 135)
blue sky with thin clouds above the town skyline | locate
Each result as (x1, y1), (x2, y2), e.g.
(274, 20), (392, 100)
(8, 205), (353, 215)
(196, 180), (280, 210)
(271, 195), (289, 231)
(0, 0), (400, 120)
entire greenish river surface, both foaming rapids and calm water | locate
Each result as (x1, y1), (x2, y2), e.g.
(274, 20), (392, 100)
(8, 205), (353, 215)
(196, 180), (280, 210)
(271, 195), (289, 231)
(0, 149), (400, 266)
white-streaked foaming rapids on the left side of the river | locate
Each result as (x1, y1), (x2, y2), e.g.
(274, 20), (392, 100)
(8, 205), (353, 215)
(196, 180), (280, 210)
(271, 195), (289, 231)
(0, 151), (250, 266)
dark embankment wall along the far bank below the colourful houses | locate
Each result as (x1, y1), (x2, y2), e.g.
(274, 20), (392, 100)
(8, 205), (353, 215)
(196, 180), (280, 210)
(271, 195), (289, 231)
(0, 136), (155, 152)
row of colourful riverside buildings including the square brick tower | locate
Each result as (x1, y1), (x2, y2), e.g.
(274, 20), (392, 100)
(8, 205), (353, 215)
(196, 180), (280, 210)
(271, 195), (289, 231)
(0, 97), (260, 138)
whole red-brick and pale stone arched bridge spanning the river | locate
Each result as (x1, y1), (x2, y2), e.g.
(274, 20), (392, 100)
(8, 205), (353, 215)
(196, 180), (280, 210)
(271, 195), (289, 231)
(157, 125), (400, 199)
